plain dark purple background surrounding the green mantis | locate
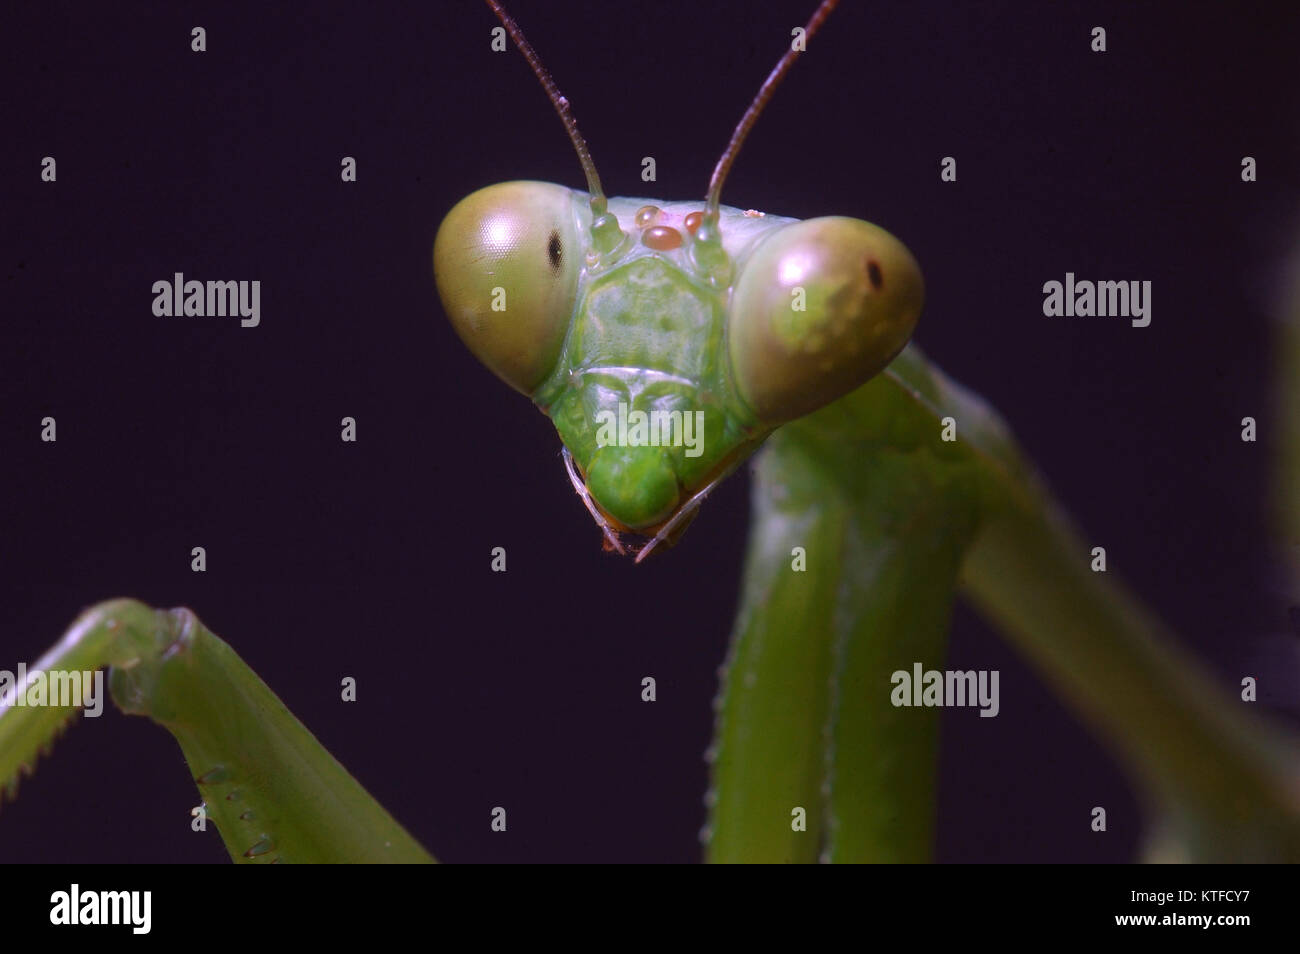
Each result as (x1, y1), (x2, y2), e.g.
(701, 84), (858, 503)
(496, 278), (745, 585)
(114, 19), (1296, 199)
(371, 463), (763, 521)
(0, 0), (1300, 862)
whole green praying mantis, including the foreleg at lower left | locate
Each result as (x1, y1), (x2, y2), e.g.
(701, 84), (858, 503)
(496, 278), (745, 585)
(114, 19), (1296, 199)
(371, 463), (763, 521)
(0, 4), (1296, 862)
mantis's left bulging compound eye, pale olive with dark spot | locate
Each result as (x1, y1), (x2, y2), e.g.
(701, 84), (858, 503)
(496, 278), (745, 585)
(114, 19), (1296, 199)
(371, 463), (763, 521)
(433, 182), (585, 394)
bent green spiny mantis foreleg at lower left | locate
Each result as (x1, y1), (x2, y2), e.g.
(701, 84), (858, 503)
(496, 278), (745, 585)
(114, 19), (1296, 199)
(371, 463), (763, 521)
(0, 599), (433, 863)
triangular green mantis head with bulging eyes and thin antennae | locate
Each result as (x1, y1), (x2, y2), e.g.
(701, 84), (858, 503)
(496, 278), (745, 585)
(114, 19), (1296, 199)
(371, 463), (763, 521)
(433, 4), (924, 559)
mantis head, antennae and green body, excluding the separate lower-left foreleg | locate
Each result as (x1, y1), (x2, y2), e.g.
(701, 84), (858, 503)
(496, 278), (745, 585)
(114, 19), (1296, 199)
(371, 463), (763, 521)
(433, 0), (1300, 860)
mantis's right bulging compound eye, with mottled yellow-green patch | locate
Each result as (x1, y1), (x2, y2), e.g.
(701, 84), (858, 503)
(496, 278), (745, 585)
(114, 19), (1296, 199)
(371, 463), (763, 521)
(728, 216), (926, 425)
